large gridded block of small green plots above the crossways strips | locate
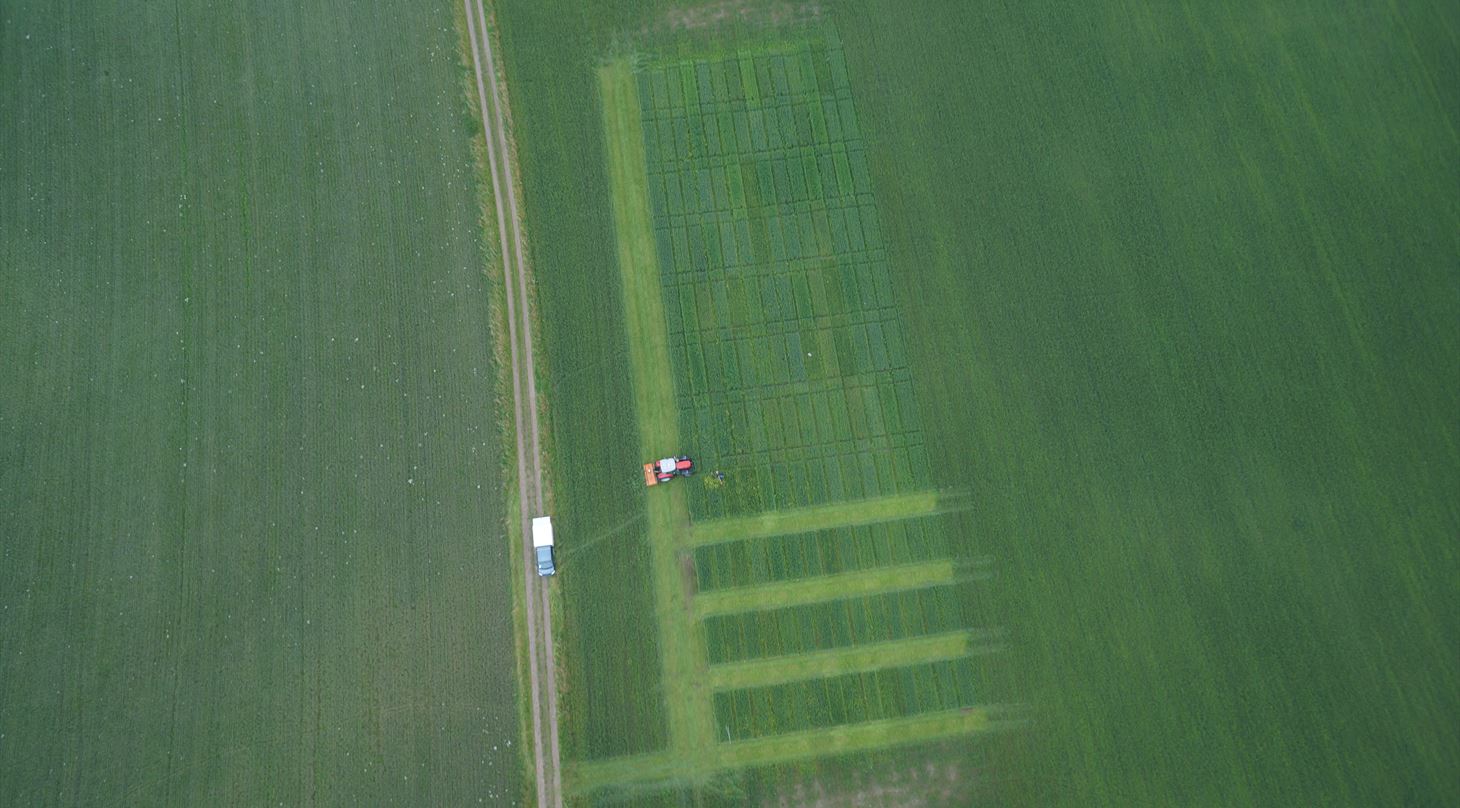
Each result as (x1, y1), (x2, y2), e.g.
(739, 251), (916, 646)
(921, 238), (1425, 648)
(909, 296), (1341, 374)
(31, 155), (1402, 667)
(638, 38), (930, 519)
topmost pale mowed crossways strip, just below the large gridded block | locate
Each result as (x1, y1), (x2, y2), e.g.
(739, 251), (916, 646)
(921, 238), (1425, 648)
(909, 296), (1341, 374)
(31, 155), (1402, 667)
(689, 491), (955, 546)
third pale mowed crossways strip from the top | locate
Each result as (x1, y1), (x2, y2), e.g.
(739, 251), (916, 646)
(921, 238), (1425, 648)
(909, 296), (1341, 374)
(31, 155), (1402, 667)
(708, 631), (999, 690)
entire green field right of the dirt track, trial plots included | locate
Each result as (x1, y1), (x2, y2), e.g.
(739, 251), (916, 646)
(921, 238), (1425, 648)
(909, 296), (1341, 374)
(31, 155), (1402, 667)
(499, 0), (1460, 805)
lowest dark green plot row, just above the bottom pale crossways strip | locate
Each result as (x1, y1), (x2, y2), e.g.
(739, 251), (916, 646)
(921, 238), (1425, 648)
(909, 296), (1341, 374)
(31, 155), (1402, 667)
(715, 658), (978, 739)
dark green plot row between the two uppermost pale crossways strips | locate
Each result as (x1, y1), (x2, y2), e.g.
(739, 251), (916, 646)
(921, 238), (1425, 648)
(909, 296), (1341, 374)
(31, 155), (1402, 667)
(695, 516), (949, 592)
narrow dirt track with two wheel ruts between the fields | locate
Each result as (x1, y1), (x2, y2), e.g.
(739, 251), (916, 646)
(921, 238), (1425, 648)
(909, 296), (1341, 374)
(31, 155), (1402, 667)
(463, 0), (562, 808)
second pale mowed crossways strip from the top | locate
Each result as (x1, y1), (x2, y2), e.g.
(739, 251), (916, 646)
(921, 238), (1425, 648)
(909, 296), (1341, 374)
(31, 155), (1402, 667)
(692, 560), (956, 618)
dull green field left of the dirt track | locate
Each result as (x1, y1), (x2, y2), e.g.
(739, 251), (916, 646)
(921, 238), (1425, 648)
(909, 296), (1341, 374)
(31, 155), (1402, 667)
(0, 1), (521, 805)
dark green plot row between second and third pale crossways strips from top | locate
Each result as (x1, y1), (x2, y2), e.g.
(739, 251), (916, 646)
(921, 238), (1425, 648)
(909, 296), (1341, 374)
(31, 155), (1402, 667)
(705, 586), (965, 665)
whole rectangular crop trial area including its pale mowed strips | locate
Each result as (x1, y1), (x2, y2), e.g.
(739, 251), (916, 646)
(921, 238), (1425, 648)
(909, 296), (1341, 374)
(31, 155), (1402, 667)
(569, 29), (999, 801)
